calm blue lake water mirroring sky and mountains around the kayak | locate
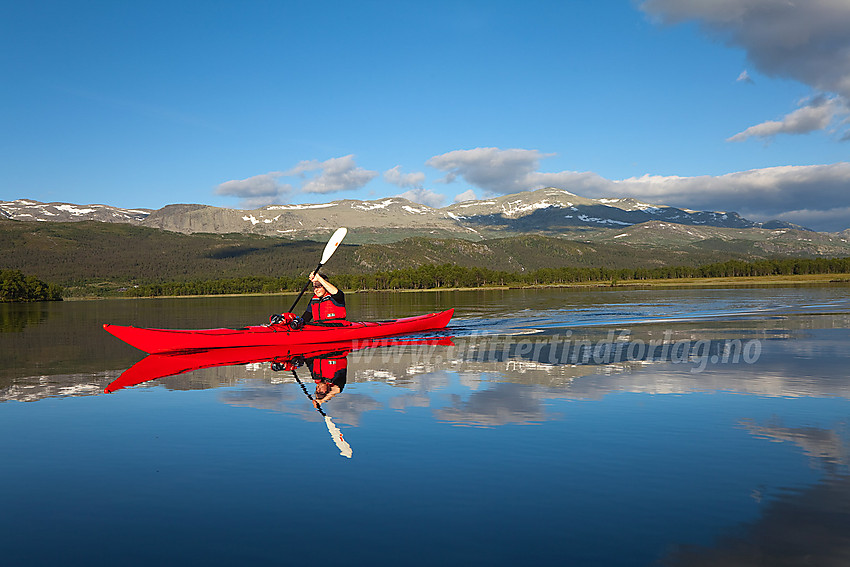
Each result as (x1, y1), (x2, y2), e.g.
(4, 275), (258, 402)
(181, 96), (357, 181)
(0, 284), (850, 566)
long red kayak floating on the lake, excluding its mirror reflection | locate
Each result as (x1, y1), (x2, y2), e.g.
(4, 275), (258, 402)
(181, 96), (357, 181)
(103, 309), (454, 354)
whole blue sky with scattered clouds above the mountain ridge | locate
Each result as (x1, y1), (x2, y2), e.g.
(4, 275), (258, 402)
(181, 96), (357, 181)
(0, 0), (850, 230)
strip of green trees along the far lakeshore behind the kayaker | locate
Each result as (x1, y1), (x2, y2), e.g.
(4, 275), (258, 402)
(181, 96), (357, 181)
(124, 257), (850, 297)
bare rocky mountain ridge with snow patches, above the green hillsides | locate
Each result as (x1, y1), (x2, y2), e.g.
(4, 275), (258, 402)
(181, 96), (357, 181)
(0, 187), (820, 244)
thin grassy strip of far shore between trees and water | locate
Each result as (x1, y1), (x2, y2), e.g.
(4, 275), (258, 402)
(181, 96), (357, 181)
(65, 273), (850, 301)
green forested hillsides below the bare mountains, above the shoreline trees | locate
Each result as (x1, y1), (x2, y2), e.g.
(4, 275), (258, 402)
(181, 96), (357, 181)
(0, 220), (844, 294)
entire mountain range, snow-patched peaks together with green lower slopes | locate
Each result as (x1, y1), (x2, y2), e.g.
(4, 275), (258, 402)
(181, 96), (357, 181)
(0, 189), (850, 296)
